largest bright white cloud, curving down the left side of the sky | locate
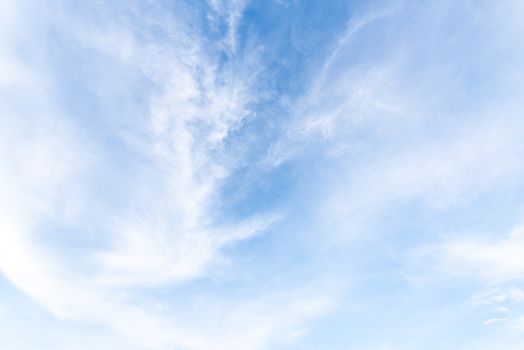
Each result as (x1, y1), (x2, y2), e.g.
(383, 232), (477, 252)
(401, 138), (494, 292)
(0, 2), (330, 350)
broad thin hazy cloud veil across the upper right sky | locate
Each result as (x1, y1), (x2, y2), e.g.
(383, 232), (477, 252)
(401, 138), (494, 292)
(266, 2), (524, 246)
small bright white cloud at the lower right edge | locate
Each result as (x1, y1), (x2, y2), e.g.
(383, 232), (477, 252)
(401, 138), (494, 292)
(412, 220), (524, 331)
